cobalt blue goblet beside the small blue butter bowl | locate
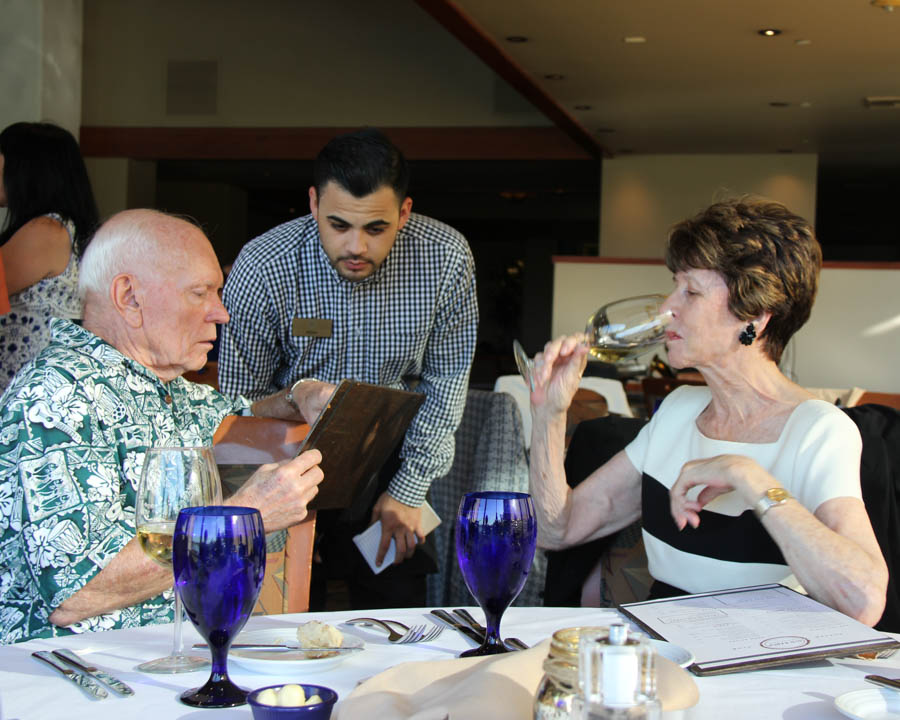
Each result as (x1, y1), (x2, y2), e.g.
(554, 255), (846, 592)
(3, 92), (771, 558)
(172, 506), (266, 708)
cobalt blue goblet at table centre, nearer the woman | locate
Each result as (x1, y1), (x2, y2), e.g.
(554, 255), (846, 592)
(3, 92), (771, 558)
(456, 492), (537, 657)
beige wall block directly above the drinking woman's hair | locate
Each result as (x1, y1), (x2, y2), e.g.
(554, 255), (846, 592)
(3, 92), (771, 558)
(599, 154), (818, 258)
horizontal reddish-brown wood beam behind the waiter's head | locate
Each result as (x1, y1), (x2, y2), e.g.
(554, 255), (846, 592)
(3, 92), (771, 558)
(80, 125), (594, 161)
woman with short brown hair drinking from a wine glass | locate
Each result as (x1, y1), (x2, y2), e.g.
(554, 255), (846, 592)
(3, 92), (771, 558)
(531, 199), (887, 625)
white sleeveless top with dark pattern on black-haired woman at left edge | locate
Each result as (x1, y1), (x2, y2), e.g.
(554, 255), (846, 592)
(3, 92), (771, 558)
(0, 213), (81, 392)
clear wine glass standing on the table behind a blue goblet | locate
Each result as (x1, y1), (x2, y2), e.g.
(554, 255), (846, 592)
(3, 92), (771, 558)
(134, 447), (222, 674)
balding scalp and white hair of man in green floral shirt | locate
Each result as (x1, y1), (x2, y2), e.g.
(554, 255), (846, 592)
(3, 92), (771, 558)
(78, 210), (213, 304)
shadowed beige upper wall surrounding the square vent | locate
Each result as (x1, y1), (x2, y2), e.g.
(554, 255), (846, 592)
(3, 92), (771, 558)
(83, 0), (551, 127)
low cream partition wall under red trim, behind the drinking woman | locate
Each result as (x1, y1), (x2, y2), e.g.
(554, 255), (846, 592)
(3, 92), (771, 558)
(552, 262), (900, 392)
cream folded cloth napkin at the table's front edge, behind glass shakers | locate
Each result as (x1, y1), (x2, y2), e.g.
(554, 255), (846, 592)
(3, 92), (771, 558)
(332, 640), (699, 720)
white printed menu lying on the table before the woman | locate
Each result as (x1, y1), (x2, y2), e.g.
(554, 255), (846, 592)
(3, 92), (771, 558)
(619, 584), (900, 675)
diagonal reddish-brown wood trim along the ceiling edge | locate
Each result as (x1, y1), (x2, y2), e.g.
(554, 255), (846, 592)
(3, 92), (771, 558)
(416, 0), (611, 160)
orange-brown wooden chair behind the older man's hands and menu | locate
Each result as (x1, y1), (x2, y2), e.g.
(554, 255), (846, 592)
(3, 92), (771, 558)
(213, 415), (316, 615)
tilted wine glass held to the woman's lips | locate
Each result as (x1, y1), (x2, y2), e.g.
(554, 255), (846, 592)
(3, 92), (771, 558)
(513, 294), (672, 390)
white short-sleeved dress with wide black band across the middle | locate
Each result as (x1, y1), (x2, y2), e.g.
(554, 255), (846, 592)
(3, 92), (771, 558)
(625, 386), (862, 597)
